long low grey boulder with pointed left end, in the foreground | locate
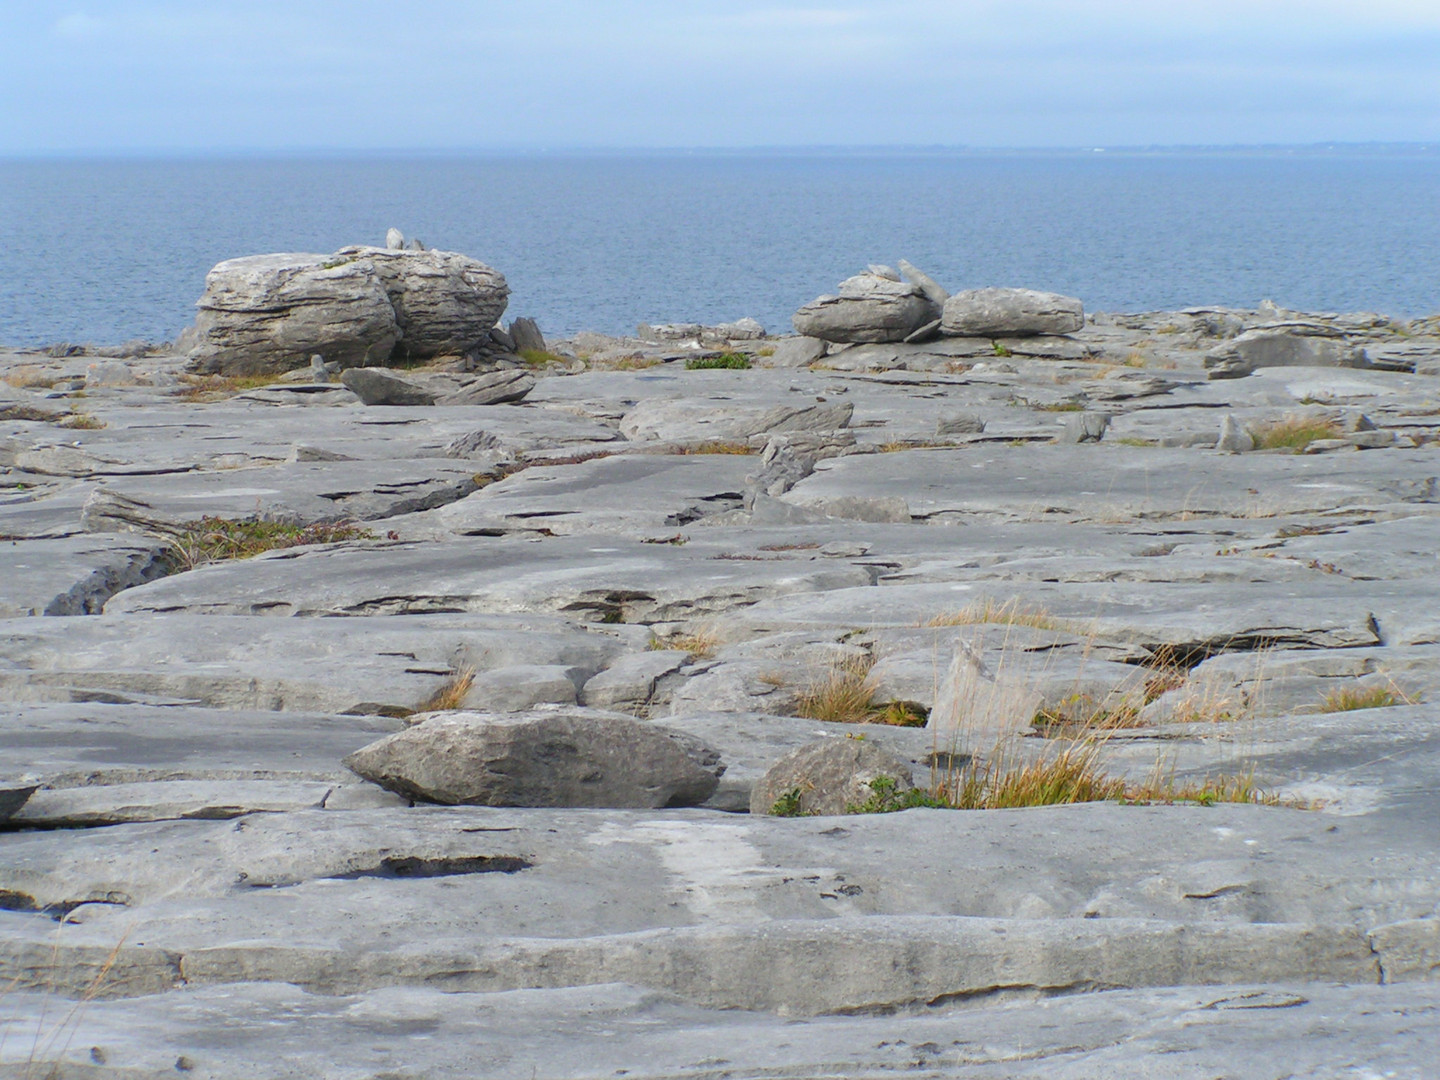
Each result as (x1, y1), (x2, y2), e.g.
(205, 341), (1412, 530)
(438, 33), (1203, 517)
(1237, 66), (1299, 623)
(344, 711), (724, 808)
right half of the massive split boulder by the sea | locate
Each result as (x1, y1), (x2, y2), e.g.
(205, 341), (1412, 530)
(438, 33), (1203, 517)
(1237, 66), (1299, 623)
(329, 246), (510, 360)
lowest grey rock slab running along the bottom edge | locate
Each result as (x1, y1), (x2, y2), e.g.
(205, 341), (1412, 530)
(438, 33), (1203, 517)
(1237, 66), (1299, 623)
(0, 982), (1440, 1080)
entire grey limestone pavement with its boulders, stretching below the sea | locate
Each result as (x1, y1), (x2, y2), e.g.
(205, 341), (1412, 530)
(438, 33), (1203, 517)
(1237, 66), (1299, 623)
(0, 285), (1440, 1080)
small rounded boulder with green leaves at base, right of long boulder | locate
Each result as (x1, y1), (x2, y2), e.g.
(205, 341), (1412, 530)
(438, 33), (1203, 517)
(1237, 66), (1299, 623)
(750, 739), (914, 816)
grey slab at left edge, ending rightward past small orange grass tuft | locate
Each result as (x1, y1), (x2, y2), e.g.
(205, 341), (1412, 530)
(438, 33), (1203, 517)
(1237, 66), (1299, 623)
(0, 615), (642, 713)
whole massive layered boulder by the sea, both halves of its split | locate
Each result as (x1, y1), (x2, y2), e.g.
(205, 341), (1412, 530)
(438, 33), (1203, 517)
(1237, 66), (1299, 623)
(186, 248), (510, 376)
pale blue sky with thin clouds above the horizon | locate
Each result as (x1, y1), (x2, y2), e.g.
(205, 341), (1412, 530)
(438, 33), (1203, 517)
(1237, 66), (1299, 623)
(0, 0), (1440, 157)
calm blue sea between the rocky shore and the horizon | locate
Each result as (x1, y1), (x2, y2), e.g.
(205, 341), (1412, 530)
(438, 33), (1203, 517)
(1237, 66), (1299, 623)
(0, 145), (1440, 346)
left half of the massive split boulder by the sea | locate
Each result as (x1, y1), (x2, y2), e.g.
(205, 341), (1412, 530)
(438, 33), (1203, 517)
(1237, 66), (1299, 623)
(190, 253), (400, 374)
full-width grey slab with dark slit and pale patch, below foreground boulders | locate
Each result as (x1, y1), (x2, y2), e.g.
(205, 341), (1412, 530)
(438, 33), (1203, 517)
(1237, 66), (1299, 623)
(0, 804), (1440, 1015)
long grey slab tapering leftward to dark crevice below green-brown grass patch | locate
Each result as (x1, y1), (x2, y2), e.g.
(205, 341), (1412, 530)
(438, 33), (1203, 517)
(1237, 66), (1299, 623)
(109, 536), (874, 622)
